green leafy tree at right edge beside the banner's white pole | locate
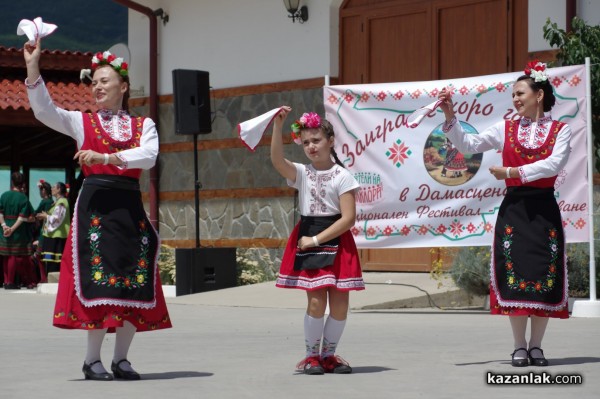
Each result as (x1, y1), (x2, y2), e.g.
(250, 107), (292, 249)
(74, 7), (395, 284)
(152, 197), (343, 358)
(544, 17), (600, 171)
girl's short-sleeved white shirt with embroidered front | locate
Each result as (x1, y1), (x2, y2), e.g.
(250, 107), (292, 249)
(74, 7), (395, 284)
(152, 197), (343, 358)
(287, 163), (360, 216)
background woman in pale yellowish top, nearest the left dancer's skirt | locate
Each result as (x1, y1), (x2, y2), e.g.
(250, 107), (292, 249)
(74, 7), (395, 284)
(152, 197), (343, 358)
(37, 182), (71, 275)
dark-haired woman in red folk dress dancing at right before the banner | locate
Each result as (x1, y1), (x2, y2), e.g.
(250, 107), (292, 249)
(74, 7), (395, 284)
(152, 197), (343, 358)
(439, 61), (571, 367)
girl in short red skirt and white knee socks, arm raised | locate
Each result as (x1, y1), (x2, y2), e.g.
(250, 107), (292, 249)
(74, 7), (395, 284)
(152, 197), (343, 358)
(271, 107), (365, 375)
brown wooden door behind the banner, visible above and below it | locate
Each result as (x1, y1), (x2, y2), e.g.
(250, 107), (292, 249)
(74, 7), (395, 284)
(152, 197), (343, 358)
(340, 0), (528, 271)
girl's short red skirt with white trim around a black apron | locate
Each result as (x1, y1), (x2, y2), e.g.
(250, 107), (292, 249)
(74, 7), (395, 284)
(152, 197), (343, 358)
(276, 223), (365, 291)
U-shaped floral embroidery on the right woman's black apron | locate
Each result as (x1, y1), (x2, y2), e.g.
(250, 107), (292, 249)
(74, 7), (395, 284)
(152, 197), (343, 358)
(502, 225), (558, 292)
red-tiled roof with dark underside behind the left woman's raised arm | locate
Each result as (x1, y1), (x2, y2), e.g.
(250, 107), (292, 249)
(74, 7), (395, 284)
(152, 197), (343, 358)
(0, 46), (95, 168)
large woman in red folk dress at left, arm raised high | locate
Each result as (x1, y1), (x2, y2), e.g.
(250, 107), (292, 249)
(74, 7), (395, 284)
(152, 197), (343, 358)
(24, 39), (171, 380)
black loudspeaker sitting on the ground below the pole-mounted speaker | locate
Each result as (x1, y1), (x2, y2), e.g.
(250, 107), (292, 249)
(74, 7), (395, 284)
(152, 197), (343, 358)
(175, 248), (237, 296)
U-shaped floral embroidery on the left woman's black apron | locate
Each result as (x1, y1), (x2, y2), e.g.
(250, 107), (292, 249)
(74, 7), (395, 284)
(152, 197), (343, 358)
(88, 215), (150, 289)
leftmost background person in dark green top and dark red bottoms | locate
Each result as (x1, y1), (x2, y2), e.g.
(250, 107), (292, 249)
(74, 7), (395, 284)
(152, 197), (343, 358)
(0, 172), (37, 290)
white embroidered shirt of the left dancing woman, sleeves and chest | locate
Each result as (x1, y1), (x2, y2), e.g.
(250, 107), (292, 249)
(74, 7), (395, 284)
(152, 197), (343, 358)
(25, 77), (158, 169)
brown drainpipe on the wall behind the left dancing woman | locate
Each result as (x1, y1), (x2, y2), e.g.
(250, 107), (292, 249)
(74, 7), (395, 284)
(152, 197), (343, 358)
(113, 0), (159, 231)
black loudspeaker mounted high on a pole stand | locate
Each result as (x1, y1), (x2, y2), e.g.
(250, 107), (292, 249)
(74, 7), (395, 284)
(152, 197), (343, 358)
(173, 69), (212, 134)
